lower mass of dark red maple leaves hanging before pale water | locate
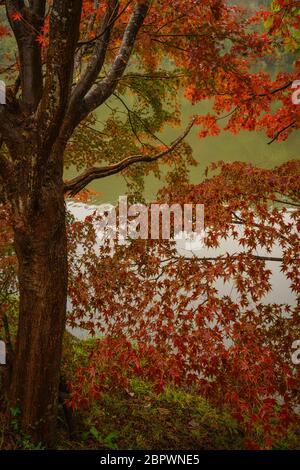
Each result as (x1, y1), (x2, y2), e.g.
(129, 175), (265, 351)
(68, 161), (300, 447)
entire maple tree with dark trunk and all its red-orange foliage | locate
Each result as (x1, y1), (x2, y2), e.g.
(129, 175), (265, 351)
(0, 0), (300, 449)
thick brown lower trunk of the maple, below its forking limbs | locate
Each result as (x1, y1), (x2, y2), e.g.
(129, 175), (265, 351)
(9, 177), (67, 446)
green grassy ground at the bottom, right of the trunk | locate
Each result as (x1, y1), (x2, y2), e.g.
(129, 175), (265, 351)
(56, 380), (243, 450)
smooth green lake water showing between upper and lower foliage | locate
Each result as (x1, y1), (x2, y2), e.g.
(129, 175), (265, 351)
(65, 98), (300, 203)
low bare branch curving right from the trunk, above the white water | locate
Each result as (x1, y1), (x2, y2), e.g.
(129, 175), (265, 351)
(65, 120), (194, 197)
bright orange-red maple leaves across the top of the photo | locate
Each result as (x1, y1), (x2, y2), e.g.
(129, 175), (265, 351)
(2, 0), (300, 149)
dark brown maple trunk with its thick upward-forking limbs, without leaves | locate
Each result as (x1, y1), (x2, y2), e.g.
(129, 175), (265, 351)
(0, 0), (150, 445)
